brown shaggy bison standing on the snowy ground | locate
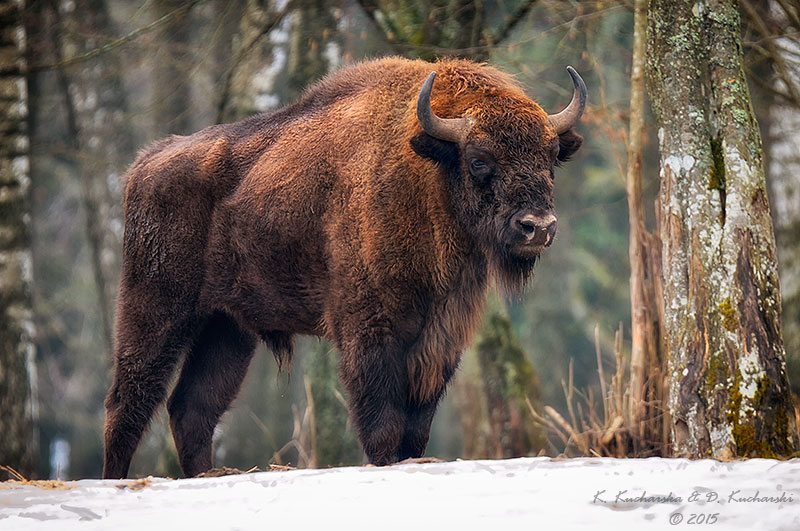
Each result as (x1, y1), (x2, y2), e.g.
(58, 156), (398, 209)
(103, 58), (586, 478)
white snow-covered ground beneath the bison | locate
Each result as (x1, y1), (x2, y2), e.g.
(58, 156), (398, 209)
(0, 458), (800, 531)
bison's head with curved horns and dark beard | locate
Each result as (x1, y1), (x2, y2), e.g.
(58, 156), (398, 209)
(411, 67), (586, 290)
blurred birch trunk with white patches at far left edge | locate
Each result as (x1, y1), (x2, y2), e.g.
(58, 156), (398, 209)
(0, 0), (36, 475)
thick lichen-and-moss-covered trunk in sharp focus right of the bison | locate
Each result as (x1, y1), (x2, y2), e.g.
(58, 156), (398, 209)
(648, 0), (798, 459)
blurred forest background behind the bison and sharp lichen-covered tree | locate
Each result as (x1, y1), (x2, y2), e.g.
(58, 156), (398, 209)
(3, 0), (800, 479)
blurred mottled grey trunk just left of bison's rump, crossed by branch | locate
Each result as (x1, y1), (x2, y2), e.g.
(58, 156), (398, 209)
(45, 0), (135, 362)
